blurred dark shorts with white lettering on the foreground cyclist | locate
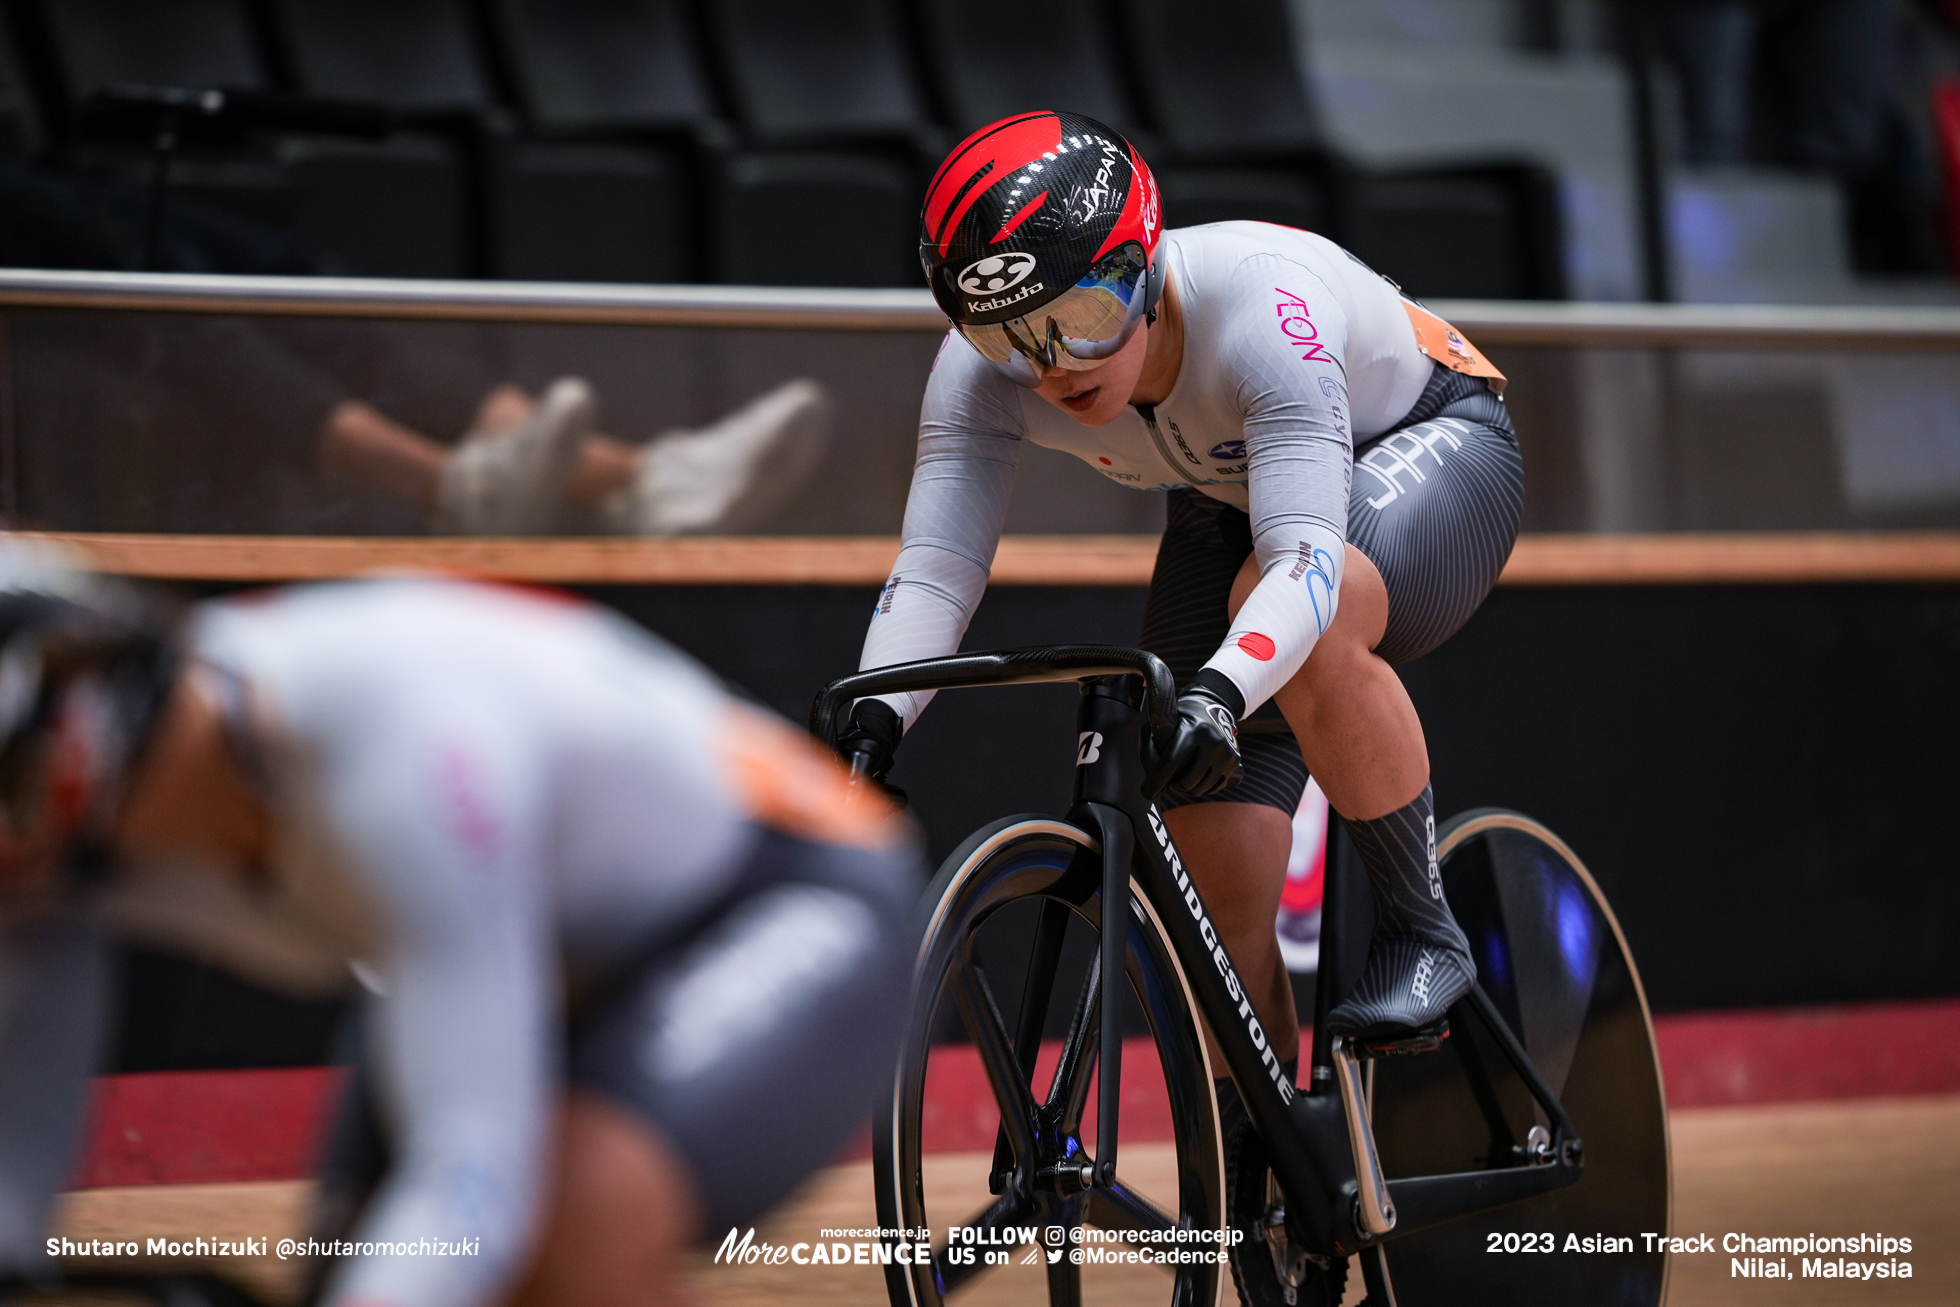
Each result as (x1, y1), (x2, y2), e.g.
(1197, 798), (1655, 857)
(308, 827), (919, 1254)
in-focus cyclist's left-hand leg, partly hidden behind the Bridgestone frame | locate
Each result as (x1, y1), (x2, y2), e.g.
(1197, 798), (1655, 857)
(1143, 490), (1307, 1070)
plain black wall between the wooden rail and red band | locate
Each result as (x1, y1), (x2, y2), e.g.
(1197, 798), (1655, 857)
(120, 586), (1960, 1070)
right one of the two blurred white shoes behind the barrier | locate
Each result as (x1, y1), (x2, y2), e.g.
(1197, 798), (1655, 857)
(604, 378), (831, 535)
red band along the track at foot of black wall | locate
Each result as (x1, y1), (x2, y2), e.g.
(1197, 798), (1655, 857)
(74, 999), (1960, 1189)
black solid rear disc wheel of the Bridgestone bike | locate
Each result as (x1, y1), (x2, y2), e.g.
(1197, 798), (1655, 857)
(1372, 809), (1672, 1307)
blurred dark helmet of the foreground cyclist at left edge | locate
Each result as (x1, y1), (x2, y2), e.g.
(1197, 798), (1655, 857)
(0, 541), (172, 882)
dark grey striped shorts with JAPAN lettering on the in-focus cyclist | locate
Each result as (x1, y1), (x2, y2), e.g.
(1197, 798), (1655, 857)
(1143, 364), (1525, 815)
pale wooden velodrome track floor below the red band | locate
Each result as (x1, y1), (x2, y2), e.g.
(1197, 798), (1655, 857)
(49, 1095), (1960, 1307)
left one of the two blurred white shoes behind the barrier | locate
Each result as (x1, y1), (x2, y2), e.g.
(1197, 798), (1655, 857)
(433, 376), (598, 535)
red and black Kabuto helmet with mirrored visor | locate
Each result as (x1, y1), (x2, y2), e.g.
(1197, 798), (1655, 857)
(919, 112), (1164, 386)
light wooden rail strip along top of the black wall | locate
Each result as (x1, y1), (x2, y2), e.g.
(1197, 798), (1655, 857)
(24, 531), (1960, 586)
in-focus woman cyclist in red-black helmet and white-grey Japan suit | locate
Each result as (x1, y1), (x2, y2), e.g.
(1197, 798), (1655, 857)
(843, 112), (1521, 1113)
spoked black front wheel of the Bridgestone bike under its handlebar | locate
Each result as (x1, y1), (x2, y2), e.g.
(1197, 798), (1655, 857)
(872, 817), (1229, 1307)
